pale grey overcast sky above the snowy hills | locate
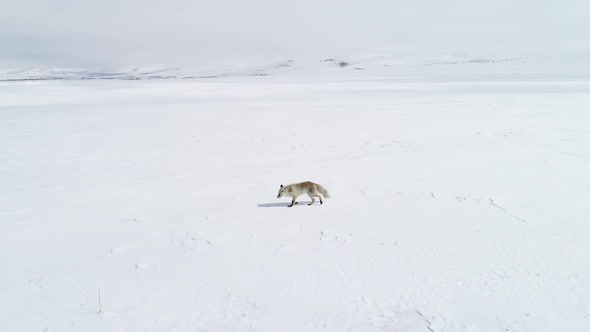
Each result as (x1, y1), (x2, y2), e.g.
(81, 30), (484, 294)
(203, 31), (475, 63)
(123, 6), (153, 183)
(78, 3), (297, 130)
(0, 0), (590, 69)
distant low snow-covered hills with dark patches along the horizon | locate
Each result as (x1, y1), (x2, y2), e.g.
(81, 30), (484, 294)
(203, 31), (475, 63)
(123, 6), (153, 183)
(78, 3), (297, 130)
(0, 54), (590, 82)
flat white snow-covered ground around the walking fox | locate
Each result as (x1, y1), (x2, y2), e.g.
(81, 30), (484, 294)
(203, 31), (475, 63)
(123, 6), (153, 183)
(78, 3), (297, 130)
(0, 72), (590, 332)
